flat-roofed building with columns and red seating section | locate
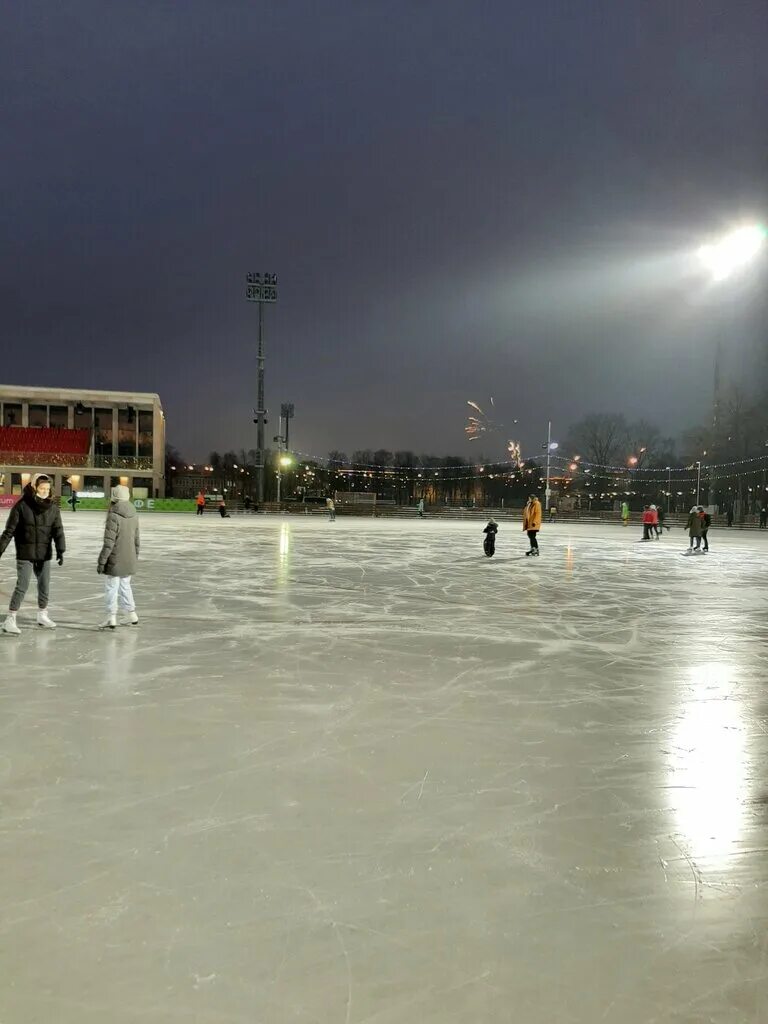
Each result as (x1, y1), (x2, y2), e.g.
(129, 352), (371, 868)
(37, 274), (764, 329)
(0, 384), (165, 498)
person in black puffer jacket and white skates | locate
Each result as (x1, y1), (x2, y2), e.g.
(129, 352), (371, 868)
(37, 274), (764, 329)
(0, 473), (67, 635)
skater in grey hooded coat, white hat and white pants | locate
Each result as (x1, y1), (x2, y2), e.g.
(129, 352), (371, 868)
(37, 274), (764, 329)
(96, 486), (139, 630)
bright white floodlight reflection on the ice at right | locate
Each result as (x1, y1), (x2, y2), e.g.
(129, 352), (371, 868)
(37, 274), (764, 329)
(669, 662), (748, 865)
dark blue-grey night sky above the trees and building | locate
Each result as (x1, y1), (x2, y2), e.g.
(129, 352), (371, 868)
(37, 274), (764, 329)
(0, 0), (768, 459)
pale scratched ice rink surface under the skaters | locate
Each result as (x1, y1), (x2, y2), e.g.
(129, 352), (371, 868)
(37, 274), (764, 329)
(0, 513), (768, 1024)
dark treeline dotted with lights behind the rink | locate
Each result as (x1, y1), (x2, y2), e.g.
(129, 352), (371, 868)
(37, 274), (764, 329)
(166, 387), (768, 515)
